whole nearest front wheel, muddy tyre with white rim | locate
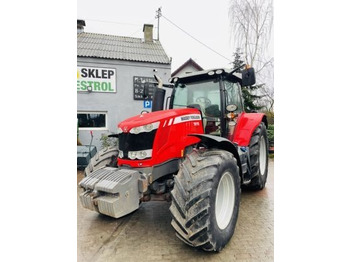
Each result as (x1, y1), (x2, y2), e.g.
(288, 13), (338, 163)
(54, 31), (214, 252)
(170, 150), (241, 251)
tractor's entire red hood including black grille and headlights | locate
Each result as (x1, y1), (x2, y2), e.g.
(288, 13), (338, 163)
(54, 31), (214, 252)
(118, 108), (203, 168)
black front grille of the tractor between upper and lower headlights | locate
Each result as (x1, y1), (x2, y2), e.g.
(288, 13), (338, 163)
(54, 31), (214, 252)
(119, 130), (157, 159)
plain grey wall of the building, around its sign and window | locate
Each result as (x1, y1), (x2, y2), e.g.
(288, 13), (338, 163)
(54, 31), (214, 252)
(77, 57), (171, 150)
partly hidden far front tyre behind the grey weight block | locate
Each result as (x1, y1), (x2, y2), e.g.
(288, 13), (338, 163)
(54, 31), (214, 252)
(84, 146), (119, 176)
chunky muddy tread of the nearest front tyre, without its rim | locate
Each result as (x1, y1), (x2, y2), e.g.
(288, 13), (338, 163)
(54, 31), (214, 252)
(170, 150), (239, 251)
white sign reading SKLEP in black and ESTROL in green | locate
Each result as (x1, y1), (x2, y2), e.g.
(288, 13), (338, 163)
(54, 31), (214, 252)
(77, 66), (117, 93)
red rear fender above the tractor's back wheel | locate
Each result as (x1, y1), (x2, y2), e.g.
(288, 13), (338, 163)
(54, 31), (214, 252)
(233, 113), (267, 146)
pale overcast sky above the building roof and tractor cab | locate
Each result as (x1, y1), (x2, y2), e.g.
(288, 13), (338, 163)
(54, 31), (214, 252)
(77, 0), (246, 71)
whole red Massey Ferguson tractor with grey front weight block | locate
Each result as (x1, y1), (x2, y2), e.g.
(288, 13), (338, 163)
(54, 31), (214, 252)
(79, 68), (268, 251)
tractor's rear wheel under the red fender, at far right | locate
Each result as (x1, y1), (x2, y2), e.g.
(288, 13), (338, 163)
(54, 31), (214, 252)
(247, 122), (269, 190)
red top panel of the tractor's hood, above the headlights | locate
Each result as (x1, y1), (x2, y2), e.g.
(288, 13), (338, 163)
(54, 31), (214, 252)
(118, 108), (198, 133)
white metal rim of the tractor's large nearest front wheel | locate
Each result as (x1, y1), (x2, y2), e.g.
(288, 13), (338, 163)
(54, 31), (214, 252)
(215, 171), (235, 229)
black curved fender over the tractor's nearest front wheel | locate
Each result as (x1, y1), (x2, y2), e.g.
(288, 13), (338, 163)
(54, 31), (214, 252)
(189, 134), (242, 177)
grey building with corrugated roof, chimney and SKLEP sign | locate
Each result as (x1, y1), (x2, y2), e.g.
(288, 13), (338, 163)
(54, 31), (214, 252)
(77, 20), (171, 149)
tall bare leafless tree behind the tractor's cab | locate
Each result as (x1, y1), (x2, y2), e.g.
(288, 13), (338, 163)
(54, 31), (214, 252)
(229, 0), (274, 110)
